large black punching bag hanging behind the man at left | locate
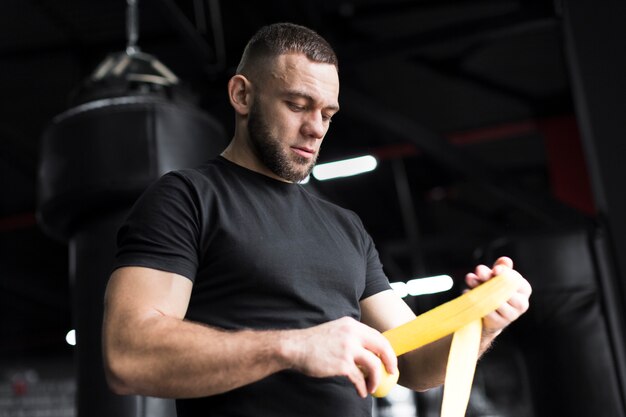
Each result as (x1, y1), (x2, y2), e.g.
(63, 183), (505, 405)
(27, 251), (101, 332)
(38, 46), (226, 417)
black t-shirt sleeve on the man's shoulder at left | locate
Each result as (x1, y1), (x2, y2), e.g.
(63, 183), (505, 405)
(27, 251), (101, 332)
(114, 173), (200, 281)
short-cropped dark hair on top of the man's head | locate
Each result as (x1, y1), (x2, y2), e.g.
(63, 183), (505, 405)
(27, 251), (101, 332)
(237, 23), (339, 74)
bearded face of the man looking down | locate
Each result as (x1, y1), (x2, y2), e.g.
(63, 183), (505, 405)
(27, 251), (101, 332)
(248, 54), (339, 182)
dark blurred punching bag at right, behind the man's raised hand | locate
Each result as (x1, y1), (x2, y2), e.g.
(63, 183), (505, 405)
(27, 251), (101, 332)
(483, 224), (626, 417)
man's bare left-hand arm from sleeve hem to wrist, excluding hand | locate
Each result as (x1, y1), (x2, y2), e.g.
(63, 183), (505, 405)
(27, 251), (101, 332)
(103, 267), (288, 397)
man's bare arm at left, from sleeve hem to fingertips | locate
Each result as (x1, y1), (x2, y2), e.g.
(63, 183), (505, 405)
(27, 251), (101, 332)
(103, 267), (396, 398)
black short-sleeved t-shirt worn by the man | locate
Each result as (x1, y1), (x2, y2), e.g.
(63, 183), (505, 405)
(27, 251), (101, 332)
(116, 157), (390, 417)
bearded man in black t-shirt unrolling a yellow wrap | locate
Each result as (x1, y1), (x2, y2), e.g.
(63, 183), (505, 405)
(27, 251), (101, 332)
(103, 24), (531, 417)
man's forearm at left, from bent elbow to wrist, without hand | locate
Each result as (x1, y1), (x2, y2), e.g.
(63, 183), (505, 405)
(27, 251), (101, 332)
(104, 316), (289, 398)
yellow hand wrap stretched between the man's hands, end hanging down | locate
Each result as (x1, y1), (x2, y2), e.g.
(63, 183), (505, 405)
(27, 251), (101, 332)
(374, 274), (520, 417)
